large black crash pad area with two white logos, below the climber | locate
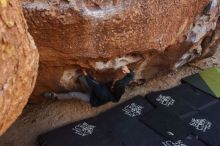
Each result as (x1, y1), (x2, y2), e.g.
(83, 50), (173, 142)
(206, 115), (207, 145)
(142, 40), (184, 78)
(39, 96), (163, 146)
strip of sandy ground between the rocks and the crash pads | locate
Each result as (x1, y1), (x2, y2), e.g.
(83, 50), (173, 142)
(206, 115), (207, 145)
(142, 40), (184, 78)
(0, 49), (220, 146)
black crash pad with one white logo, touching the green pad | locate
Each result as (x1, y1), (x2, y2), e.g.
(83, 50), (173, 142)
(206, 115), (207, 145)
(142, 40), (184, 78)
(146, 84), (218, 116)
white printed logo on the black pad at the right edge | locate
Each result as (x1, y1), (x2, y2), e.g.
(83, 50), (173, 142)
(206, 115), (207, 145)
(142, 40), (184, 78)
(189, 118), (212, 132)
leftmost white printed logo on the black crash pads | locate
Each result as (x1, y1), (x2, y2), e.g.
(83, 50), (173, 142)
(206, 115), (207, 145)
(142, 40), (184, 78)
(72, 122), (96, 136)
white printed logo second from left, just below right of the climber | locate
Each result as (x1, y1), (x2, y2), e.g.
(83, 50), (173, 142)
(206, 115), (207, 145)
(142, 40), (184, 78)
(122, 103), (144, 117)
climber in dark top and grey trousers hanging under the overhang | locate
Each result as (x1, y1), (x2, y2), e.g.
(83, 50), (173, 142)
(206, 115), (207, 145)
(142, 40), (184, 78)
(43, 66), (134, 107)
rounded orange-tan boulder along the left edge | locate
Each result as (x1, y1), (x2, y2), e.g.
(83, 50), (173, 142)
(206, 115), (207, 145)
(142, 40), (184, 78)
(0, 0), (38, 135)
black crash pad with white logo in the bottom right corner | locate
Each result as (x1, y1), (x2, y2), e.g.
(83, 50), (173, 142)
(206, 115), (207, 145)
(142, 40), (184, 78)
(183, 102), (220, 146)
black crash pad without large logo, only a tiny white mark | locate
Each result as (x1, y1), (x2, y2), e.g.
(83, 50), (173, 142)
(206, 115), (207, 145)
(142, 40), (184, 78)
(140, 108), (193, 141)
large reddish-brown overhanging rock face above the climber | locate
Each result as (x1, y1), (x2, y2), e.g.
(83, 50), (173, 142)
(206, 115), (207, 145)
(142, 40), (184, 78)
(23, 0), (219, 99)
